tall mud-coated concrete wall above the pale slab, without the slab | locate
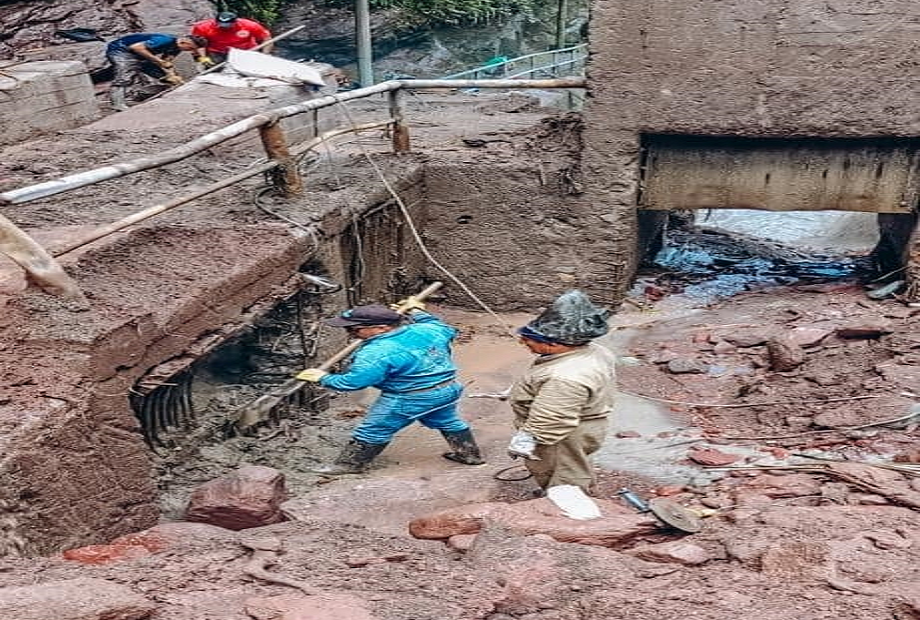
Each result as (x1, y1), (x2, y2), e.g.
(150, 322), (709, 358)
(584, 0), (920, 288)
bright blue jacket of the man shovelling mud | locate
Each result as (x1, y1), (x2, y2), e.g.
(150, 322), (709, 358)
(320, 311), (457, 393)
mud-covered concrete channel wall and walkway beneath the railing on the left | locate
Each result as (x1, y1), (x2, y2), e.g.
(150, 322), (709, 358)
(0, 81), (584, 556)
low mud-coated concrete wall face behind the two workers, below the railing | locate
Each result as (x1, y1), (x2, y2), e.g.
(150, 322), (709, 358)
(423, 162), (618, 310)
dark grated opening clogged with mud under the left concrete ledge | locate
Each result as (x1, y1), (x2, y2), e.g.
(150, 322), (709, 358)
(130, 267), (370, 519)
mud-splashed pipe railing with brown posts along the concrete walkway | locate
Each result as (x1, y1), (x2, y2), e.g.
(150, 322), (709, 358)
(0, 78), (585, 298)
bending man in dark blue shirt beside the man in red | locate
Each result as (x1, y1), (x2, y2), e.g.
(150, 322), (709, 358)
(105, 32), (207, 110)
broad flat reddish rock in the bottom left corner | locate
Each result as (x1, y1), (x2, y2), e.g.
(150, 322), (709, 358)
(0, 578), (157, 620)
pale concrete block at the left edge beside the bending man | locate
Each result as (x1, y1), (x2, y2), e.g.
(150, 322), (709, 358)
(0, 61), (99, 145)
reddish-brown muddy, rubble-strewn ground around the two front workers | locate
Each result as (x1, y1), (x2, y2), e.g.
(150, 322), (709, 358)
(0, 287), (920, 620)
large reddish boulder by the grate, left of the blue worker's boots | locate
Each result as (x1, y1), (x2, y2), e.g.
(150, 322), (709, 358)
(185, 465), (286, 530)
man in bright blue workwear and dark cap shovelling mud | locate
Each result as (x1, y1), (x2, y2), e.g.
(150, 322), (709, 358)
(297, 297), (485, 476)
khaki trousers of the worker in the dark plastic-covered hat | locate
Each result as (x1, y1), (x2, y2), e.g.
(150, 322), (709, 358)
(524, 418), (607, 493)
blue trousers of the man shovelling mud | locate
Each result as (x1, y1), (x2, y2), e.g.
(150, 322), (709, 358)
(352, 383), (470, 444)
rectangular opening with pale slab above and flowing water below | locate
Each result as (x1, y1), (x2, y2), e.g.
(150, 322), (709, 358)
(638, 135), (920, 299)
